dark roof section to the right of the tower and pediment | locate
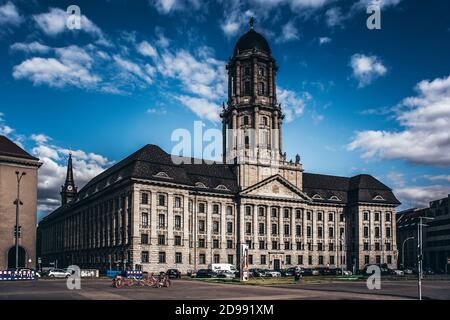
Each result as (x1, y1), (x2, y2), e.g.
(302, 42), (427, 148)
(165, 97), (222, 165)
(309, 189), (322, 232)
(303, 172), (400, 205)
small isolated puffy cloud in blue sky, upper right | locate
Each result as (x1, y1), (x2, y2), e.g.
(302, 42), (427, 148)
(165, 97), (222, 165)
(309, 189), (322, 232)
(350, 53), (387, 88)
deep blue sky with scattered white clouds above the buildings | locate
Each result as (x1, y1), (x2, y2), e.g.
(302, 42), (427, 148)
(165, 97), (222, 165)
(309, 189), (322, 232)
(0, 0), (450, 220)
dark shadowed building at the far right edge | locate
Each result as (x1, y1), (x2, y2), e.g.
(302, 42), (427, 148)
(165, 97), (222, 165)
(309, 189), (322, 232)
(397, 195), (450, 272)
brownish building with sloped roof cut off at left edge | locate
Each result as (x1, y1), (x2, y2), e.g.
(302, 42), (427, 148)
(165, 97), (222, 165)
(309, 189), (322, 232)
(0, 136), (41, 270)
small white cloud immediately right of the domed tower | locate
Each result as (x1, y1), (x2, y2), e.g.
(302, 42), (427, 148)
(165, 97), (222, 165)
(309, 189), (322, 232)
(277, 87), (312, 123)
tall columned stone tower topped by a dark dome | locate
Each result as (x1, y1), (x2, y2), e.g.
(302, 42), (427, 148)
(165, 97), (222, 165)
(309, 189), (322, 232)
(221, 18), (301, 188)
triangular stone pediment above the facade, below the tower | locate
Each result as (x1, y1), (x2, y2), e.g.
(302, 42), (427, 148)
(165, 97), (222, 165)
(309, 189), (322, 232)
(241, 175), (311, 201)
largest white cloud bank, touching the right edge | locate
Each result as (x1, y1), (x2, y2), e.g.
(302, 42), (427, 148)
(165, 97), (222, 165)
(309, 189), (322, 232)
(348, 76), (450, 166)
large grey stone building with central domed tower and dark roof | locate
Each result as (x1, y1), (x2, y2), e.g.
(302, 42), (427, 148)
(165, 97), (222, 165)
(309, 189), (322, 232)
(39, 24), (399, 272)
